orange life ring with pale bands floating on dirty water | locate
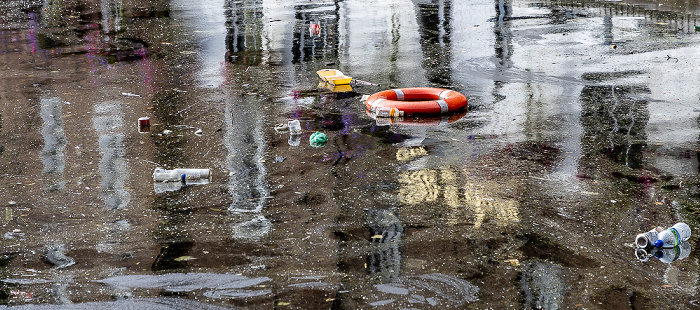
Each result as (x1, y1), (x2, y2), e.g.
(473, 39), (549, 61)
(365, 87), (467, 115)
